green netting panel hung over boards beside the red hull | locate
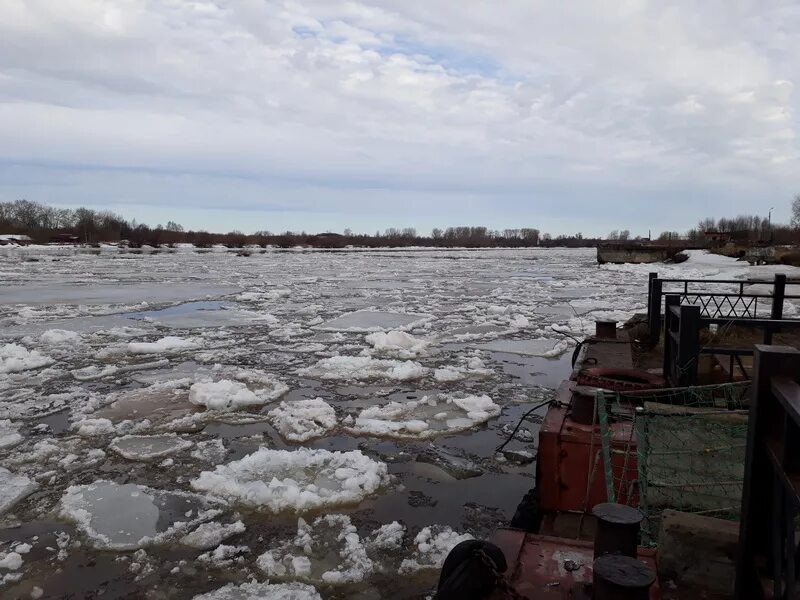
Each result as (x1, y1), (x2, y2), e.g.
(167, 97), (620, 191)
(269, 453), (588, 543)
(597, 382), (750, 544)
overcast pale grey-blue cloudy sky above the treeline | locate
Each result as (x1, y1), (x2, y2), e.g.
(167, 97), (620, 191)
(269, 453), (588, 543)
(0, 0), (800, 235)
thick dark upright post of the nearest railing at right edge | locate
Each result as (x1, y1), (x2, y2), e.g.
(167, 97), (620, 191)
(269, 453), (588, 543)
(736, 345), (800, 600)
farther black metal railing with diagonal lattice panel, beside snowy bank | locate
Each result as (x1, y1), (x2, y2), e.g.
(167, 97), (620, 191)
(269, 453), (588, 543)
(647, 273), (800, 343)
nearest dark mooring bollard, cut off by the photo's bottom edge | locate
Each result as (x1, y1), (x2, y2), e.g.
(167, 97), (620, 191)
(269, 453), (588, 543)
(593, 554), (656, 600)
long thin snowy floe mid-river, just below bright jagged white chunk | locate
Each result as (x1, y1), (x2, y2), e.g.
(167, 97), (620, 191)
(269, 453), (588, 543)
(298, 356), (429, 381)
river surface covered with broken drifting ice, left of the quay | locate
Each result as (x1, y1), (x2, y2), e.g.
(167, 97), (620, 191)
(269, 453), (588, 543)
(0, 247), (796, 600)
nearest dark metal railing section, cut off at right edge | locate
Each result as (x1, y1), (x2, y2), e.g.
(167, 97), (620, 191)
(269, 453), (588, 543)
(736, 346), (800, 600)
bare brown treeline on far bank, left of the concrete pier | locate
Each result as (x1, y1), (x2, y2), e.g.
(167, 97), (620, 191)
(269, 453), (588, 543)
(0, 200), (599, 248)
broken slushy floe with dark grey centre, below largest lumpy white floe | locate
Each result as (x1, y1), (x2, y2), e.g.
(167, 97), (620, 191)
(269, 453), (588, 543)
(256, 515), (374, 584)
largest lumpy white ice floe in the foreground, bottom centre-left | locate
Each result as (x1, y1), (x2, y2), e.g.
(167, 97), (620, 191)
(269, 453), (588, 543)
(192, 448), (389, 513)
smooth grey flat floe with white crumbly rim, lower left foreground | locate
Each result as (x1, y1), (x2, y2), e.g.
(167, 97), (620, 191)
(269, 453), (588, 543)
(60, 480), (220, 550)
